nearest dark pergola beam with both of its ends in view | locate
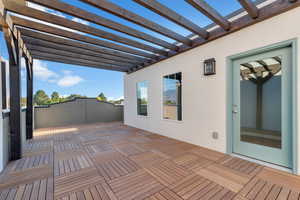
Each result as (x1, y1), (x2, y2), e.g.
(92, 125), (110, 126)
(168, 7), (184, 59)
(11, 16), (157, 59)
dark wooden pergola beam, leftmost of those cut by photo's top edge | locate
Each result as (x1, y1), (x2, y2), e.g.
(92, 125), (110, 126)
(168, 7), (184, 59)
(29, 0), (178, 51)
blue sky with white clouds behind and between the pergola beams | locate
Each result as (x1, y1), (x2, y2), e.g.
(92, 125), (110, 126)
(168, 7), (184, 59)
(0, 0), (241, 100)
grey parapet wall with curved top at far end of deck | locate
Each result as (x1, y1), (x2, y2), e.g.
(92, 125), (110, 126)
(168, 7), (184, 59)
(34, 98), (123, 128)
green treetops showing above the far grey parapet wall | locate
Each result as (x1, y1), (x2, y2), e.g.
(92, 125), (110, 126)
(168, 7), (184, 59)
(33, 90), (123, 105)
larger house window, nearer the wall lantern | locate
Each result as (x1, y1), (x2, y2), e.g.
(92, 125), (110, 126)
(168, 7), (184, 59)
(163, 72), (182, 121)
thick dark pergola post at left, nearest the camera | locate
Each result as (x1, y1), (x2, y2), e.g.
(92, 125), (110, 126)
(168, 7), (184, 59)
(3, 28), (22, 160)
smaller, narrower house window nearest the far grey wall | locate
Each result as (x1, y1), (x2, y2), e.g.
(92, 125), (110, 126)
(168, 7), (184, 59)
(137, 81), (148, 116)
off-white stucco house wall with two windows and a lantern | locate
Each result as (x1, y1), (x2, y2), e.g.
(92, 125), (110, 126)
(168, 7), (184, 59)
(124, 8), (300, 174)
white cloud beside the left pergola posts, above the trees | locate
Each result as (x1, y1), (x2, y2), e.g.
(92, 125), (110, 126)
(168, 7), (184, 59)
(33, 60), (59, 81)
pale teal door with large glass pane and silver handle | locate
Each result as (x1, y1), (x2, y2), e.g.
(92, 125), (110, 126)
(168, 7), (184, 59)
(232, 47), (293, 168)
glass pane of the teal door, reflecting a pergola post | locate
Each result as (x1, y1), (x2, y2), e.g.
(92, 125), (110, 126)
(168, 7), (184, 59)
(240, 56), (282, 149)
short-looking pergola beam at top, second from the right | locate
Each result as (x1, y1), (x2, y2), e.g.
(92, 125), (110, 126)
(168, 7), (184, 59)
(185, 0), (230, 31)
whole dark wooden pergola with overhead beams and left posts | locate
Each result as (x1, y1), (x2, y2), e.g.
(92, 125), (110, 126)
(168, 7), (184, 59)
(0, 0), (300, 160)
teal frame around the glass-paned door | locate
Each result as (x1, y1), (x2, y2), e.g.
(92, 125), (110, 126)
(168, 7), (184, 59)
(226, 38), (299, 174)
